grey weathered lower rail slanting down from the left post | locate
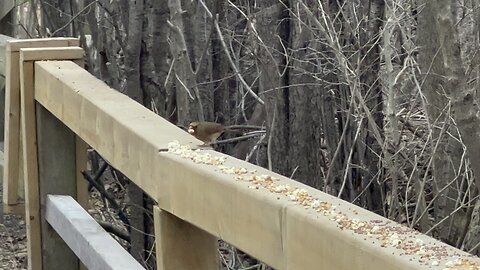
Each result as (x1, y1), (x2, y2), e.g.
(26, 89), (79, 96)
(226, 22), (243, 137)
(45, 195), (145, 270)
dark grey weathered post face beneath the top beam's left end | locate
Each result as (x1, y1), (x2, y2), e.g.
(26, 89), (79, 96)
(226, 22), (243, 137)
(35, 104), (79, 270)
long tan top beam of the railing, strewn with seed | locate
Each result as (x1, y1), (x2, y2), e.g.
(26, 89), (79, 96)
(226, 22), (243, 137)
(29, 61), (480, 269)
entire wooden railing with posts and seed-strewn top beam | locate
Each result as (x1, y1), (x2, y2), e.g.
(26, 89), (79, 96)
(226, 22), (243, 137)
(4, 37), (480, 270)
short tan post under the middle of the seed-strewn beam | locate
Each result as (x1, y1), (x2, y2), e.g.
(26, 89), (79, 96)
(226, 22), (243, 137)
(153, 206), (219, 270)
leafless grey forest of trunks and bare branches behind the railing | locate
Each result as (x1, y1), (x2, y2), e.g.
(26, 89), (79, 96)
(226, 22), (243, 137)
(2, 0), (480, 269)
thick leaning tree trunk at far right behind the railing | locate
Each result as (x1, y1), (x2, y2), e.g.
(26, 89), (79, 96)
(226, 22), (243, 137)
(418, 1), (468, 244)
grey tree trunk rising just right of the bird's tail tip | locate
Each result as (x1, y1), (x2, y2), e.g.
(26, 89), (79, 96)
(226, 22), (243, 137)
(256, 0), (292, 176)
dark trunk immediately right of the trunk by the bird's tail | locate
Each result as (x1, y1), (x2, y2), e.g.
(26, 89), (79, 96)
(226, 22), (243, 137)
(288, 1), (324, 189)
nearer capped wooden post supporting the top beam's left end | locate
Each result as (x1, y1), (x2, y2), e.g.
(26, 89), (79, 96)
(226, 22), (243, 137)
(20, 47), (86, 270)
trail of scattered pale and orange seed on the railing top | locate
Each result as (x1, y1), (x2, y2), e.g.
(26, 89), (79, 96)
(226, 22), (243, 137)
(168, 141), (480, 270)
